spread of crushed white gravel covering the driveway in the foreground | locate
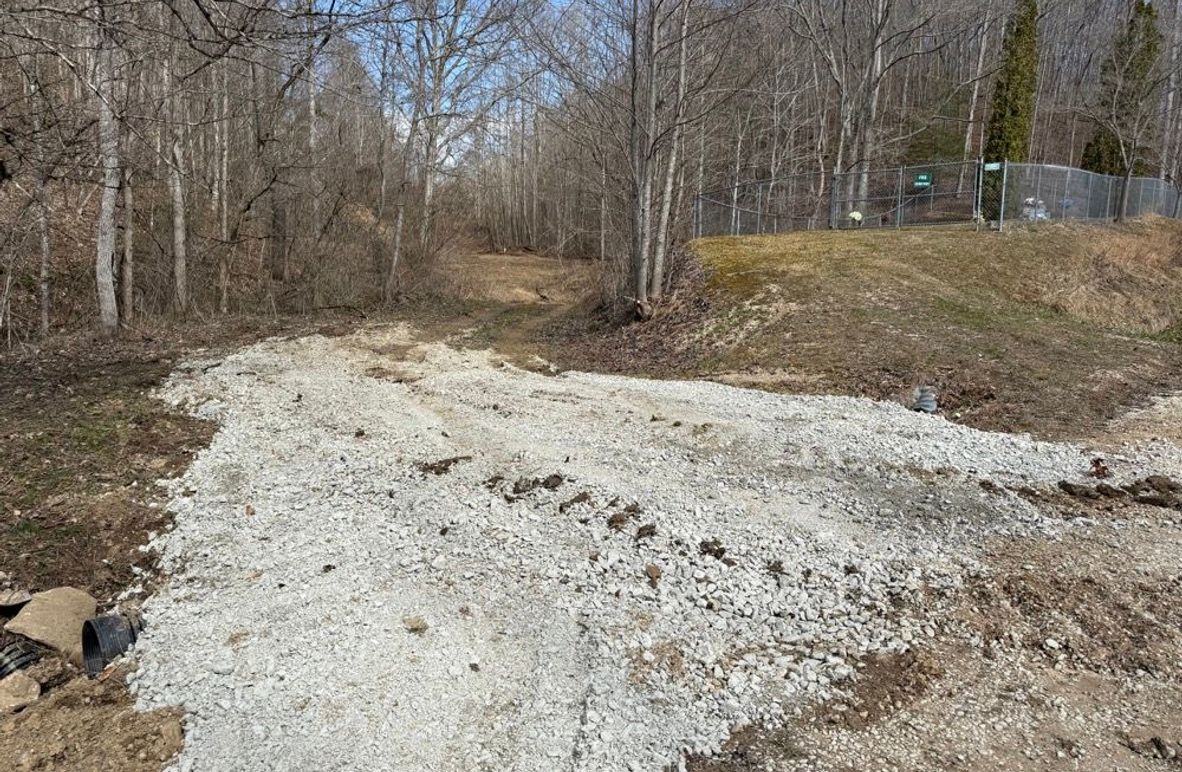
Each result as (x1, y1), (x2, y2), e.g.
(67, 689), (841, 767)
(132, 326), (1172, 772)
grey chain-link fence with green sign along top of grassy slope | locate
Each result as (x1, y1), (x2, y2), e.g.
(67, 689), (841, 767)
(694, 161), (1182, 236)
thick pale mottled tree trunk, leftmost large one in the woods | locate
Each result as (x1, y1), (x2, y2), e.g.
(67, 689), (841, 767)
(95, 16), (119, 336)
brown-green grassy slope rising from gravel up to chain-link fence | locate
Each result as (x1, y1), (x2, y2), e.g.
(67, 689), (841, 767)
(550, 220), (1182, 436)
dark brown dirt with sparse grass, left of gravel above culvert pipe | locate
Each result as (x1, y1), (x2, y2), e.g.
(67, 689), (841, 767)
(0, 353), (213, 601)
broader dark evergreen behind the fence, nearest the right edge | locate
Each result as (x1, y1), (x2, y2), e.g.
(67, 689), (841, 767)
(1080, 0), (1162, 176)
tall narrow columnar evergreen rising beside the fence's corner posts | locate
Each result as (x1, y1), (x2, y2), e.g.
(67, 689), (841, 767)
(985, 0), (1038, 161)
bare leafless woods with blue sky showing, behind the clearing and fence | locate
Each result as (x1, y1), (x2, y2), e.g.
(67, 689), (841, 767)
(0, 0), (1182, 345)
